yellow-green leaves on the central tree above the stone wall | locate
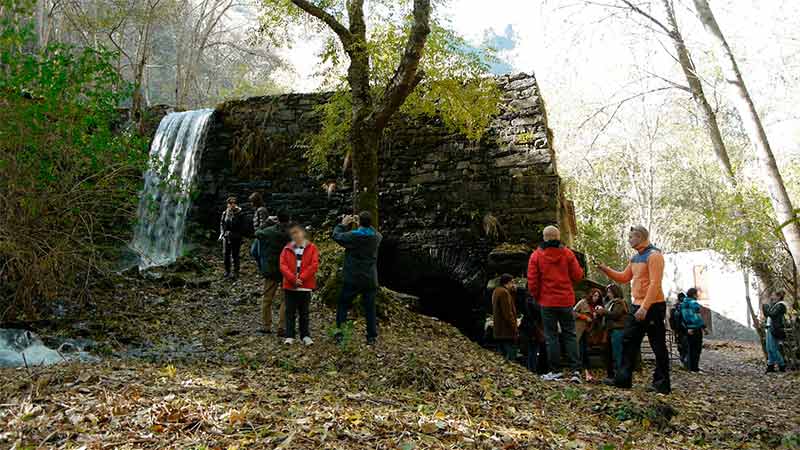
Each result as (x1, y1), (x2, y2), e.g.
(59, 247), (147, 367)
(262, 0), (500, 175)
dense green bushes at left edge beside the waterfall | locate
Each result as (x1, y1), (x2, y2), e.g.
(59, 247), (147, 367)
(0, 0), (146, 317)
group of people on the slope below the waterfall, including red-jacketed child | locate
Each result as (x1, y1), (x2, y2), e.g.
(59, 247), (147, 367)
(219, 192), (382, 346)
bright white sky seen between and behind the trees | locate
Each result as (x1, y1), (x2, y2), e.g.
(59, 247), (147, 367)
(270, 0), (800, 162)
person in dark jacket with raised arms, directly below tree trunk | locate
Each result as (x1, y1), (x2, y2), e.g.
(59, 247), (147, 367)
(333, 211), (383, 344)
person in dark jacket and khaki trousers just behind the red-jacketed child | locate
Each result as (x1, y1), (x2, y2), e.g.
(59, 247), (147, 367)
(256, 212), (291, 336)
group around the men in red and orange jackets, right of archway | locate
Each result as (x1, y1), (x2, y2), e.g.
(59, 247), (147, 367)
(492, 226), (672, 394)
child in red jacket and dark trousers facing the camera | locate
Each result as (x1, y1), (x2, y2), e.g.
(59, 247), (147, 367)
(281, 223), (319, 345)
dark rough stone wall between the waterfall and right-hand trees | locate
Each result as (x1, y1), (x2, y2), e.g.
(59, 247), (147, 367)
(191, 74), (568, 334)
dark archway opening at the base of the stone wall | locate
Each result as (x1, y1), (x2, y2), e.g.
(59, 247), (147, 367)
(378, 239), (487, 342)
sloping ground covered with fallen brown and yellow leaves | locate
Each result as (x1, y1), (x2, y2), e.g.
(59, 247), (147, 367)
(0, 251), (800, 450)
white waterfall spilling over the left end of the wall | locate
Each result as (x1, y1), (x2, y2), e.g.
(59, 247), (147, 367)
(130, 109), (214, 269)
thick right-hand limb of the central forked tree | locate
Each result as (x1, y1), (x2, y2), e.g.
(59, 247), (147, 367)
(373, 0), (431, 129)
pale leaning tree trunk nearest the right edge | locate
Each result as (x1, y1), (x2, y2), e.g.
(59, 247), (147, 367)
(694, 0), (800, 272)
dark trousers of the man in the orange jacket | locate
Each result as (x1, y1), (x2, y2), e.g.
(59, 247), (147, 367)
(615, 302), (672, 393)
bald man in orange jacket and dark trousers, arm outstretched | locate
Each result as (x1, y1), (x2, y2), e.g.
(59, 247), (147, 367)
(597, 225), (672, 394)
